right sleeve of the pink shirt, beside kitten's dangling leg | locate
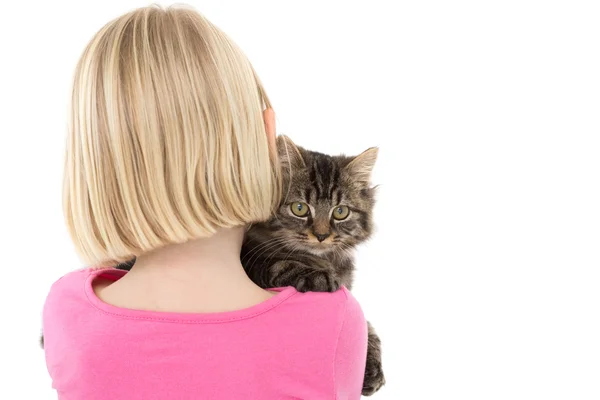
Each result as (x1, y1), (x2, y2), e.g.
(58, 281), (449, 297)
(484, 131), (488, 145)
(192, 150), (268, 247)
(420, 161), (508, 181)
(334, 288), (367, 400)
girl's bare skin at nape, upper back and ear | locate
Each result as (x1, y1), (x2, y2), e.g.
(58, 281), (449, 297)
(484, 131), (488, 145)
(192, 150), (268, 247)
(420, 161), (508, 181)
(94, 109), (275, 313)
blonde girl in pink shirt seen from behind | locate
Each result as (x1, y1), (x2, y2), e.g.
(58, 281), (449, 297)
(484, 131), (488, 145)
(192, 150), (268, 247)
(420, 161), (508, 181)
(43, 6), (367, 400)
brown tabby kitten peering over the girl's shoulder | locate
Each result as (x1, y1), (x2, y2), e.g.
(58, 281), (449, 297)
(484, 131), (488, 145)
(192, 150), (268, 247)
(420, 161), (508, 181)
(241, 136), (385, 396)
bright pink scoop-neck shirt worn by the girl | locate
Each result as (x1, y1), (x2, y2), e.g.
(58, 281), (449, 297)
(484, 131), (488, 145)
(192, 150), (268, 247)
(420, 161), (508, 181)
(43, 269), (367, 400)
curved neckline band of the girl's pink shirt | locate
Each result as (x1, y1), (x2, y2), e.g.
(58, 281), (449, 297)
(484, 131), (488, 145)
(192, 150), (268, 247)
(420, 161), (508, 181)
(84, 268), (298, 323)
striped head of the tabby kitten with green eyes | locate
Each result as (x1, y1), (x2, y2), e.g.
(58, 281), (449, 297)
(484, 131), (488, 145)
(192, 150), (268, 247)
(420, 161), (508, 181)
(267, 136), (378, 255)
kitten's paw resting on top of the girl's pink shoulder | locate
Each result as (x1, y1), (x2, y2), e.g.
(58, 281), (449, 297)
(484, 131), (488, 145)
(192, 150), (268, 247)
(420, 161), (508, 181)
(270, 260), (340, 292)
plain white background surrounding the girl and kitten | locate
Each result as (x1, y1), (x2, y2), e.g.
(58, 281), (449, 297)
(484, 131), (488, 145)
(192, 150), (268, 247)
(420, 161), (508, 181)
(0, 0), (600, 400)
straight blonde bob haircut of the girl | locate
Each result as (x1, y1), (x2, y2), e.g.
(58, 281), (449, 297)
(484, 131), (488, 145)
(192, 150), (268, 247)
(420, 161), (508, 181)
(63, 6), (281, 266)
